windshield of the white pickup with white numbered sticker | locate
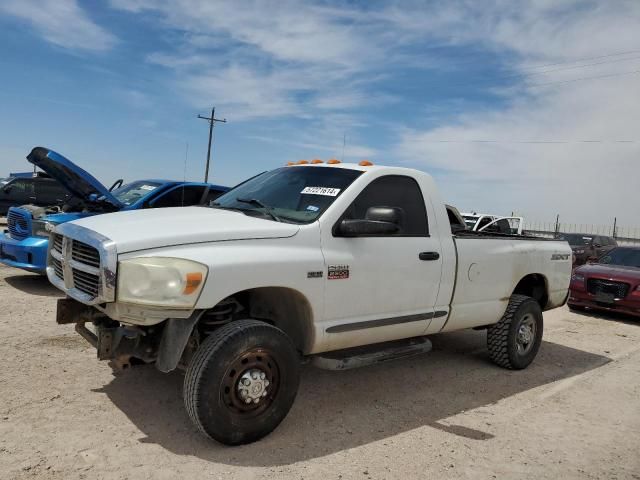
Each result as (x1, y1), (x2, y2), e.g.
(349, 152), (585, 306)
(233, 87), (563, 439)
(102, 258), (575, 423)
(211, 167), (362, 223)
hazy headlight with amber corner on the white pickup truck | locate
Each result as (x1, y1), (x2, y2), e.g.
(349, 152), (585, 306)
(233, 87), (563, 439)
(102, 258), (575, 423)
(118, 257), (208, 308)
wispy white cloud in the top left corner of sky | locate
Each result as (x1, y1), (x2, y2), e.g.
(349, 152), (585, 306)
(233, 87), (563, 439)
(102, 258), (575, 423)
(0, 0), (116, 51)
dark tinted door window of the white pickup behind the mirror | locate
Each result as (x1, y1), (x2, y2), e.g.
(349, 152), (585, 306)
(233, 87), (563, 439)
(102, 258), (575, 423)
(342, 175), (429, 237)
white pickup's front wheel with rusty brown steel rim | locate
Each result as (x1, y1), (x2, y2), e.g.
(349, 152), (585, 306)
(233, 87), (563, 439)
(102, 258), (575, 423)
(184, 320), (300, 445)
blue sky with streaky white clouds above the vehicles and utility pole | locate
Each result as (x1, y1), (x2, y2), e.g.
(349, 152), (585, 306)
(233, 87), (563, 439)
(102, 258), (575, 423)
(0, 0), (640, 225)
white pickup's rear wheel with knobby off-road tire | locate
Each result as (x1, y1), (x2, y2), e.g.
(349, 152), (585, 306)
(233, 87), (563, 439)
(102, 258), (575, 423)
(487, 295), (543, 370)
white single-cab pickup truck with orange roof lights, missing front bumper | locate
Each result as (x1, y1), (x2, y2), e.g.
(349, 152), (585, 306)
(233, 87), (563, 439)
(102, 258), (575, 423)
(47, 161), (571, 445)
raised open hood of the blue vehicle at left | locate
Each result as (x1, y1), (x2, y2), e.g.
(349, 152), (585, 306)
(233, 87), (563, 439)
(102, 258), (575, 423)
(27, 147), (125, 209)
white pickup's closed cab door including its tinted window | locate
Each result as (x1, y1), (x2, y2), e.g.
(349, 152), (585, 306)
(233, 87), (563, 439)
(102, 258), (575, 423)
(322, 176), (442, 349)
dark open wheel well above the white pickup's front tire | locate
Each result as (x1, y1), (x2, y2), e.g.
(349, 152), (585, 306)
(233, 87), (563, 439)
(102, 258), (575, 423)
(201, 287), (314, 353)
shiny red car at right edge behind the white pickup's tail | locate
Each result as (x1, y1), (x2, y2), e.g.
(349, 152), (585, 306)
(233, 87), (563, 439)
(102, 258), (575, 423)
(568, 247), (640, 317)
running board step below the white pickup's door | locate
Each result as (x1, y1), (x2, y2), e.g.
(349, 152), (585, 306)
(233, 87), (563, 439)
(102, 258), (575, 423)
(311, 337), (431, 370)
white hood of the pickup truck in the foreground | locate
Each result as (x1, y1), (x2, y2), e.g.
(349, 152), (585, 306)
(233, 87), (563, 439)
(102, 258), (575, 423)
(56, 207), (299, 253)
